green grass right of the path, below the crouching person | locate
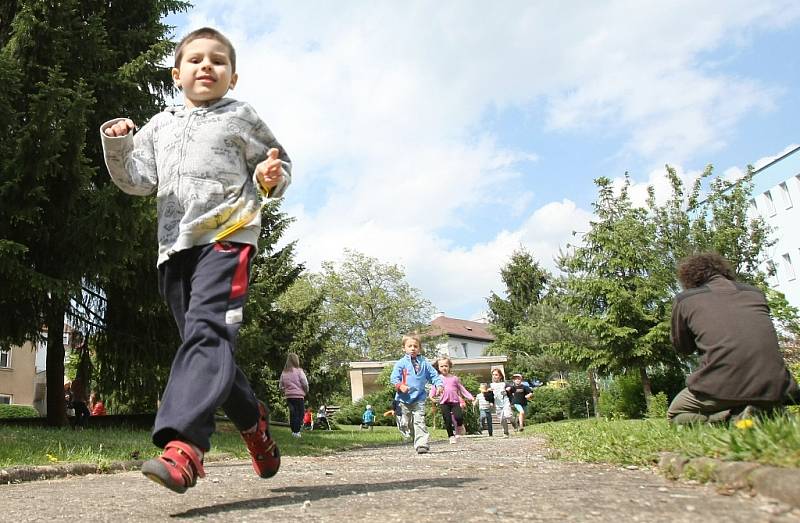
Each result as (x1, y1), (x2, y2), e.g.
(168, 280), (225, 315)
(529, 415), (800, 468)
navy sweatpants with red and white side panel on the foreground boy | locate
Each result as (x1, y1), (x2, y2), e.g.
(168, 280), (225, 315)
(153, 242), (258, 451)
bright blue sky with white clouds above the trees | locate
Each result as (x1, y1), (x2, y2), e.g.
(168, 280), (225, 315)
(167, 0), (800, 319)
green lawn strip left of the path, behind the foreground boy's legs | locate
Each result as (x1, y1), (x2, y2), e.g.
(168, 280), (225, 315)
(0, 422), (424, 467)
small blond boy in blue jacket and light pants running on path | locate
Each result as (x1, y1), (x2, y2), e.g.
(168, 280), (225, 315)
(389, 335), (444, 454)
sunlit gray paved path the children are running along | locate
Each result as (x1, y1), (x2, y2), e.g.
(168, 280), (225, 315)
(0, 437), (800, 523)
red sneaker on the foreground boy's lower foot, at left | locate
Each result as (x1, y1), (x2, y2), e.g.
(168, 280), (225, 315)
(142, 440), (206, 494)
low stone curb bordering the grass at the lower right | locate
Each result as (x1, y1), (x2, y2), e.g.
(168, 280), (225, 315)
(658, 452), (800, 508)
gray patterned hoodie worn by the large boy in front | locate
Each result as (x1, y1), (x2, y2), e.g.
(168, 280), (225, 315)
(100, 98), (291, 265)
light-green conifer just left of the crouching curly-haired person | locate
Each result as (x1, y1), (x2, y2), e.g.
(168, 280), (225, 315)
(559, 176), (676, 398)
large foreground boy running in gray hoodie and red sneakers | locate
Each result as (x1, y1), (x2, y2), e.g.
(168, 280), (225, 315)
(100, 27), (291, 493)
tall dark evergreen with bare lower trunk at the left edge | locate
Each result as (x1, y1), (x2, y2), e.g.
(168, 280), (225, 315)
(0, 0), (188, 424)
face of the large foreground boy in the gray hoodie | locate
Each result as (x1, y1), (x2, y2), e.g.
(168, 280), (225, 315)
(172, 38), (239, 107)
